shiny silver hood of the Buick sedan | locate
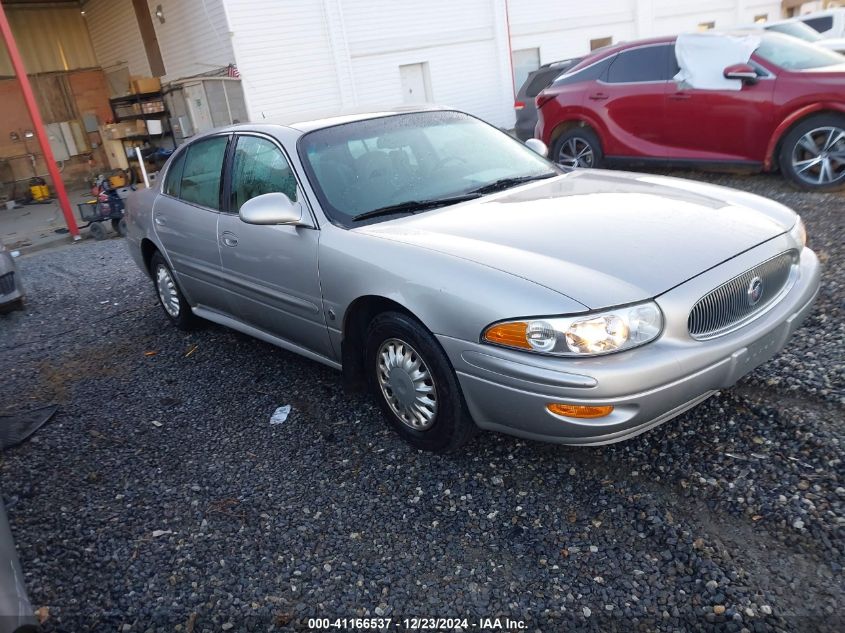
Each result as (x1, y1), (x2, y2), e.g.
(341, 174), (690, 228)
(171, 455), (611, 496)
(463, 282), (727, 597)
(355, 170), (795, 309)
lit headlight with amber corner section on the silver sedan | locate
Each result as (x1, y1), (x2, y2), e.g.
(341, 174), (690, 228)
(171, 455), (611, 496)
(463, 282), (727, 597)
(481, 301), (663, 356)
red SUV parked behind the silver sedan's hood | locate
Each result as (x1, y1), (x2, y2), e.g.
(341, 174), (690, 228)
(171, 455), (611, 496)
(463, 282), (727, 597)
(535, 33), (845, 190)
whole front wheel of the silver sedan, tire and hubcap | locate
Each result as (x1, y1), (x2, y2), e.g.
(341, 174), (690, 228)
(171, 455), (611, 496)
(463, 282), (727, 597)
(365, 312), (476, 452)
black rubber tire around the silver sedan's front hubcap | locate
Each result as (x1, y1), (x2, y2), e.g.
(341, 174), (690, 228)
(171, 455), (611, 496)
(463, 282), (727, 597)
(364, 312), (477, 453)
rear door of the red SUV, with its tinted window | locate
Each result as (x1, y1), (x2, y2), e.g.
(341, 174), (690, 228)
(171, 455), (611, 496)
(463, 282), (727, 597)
(596, 44), (672, 156)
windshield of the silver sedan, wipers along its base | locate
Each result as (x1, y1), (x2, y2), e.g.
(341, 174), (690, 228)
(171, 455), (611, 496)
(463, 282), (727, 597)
(299, 111), (561, 227)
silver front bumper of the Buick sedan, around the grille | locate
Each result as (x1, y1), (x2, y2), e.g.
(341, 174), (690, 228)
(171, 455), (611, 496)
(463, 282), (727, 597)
(438, 240), (820, 445)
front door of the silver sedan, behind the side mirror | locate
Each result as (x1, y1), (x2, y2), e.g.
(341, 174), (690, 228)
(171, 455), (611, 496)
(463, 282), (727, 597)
(217, 134), (331, 356)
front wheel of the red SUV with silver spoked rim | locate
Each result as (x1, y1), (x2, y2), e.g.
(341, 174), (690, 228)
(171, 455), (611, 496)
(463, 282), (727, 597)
(778, 114), (845, 191)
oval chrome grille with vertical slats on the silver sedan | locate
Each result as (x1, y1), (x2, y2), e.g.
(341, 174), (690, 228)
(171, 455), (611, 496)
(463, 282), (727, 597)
(687, 251), (798, 340)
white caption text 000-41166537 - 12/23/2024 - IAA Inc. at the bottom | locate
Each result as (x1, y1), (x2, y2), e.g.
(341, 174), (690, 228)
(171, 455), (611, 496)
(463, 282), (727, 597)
(308, 617), (527, 631)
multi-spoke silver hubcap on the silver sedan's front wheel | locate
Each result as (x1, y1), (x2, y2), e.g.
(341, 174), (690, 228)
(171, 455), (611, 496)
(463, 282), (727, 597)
(376, 338), (437, 431)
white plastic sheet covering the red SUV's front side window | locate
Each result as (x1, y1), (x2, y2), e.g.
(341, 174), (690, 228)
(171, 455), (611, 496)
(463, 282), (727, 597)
(675, 33), (760, 90)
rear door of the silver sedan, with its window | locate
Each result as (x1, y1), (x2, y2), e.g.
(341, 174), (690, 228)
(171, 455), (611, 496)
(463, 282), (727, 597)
(153, 134), (229, 310)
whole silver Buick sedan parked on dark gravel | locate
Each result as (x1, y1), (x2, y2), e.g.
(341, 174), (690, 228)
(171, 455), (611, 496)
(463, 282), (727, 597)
(127, 110), (819, 451)
